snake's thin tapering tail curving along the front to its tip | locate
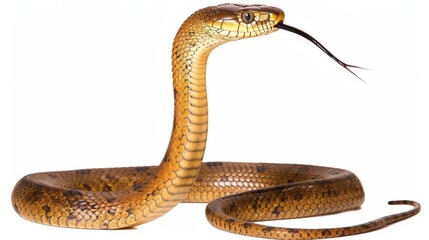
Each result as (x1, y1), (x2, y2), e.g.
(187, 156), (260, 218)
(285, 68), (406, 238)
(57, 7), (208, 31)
(206, 197), (421, 240)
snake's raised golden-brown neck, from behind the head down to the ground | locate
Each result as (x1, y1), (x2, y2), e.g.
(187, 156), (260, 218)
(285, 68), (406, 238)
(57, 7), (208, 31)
(138, 11), (222, 222)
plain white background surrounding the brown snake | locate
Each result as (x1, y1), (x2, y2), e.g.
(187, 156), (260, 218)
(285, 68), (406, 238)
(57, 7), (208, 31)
(0, 0), (429, 240)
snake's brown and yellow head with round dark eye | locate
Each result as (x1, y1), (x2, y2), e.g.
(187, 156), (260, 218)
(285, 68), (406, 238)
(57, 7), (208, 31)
(206, 4), (285, 41)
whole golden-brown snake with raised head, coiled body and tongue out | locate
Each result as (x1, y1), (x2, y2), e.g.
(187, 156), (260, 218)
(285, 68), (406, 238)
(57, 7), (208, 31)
(12, 4), (421, 239)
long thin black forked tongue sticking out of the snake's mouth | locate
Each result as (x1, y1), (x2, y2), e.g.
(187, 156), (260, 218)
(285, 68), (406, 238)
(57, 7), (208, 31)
(274, 21), (365, 82)
